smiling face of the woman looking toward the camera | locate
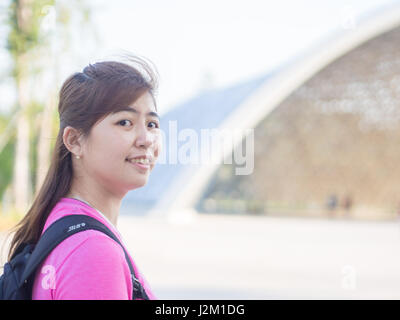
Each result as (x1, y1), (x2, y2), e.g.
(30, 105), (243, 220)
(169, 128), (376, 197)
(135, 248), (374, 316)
(80, 92), (161, 193)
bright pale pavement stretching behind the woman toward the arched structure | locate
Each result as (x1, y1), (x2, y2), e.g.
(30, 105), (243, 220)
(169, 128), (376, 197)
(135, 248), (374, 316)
(0, 214), (400, 300)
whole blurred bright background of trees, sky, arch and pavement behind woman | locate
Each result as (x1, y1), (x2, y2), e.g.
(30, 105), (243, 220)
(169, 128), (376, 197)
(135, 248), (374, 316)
(0, 0), (400, 299)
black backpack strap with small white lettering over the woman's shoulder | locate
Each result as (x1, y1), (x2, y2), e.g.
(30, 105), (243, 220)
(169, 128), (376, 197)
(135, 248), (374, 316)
(20, 214), (149, 300)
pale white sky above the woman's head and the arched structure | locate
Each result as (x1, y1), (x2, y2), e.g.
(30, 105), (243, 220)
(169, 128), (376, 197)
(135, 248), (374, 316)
(0, 0), (400, 114)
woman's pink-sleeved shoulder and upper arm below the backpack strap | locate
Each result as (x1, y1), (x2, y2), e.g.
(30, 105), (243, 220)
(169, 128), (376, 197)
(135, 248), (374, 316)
(35, 230), (131, 299)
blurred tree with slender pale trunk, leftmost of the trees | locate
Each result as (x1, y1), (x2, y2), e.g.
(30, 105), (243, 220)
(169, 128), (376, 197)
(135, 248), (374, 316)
(7, 0), (54, 212)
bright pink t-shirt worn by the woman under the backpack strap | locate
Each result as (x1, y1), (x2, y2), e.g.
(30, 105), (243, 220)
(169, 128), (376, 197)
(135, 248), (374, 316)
(32, 198), (156, 300)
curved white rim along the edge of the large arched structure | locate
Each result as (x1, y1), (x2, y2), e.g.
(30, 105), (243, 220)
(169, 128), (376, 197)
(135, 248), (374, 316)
(145, 6), (400, 219)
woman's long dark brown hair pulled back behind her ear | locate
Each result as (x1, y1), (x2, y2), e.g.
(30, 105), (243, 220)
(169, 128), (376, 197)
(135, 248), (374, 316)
(8, 56), (157, 260)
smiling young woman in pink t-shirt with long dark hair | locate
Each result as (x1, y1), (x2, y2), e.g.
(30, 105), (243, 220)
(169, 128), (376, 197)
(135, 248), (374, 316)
(5, 58), (160, 300)
